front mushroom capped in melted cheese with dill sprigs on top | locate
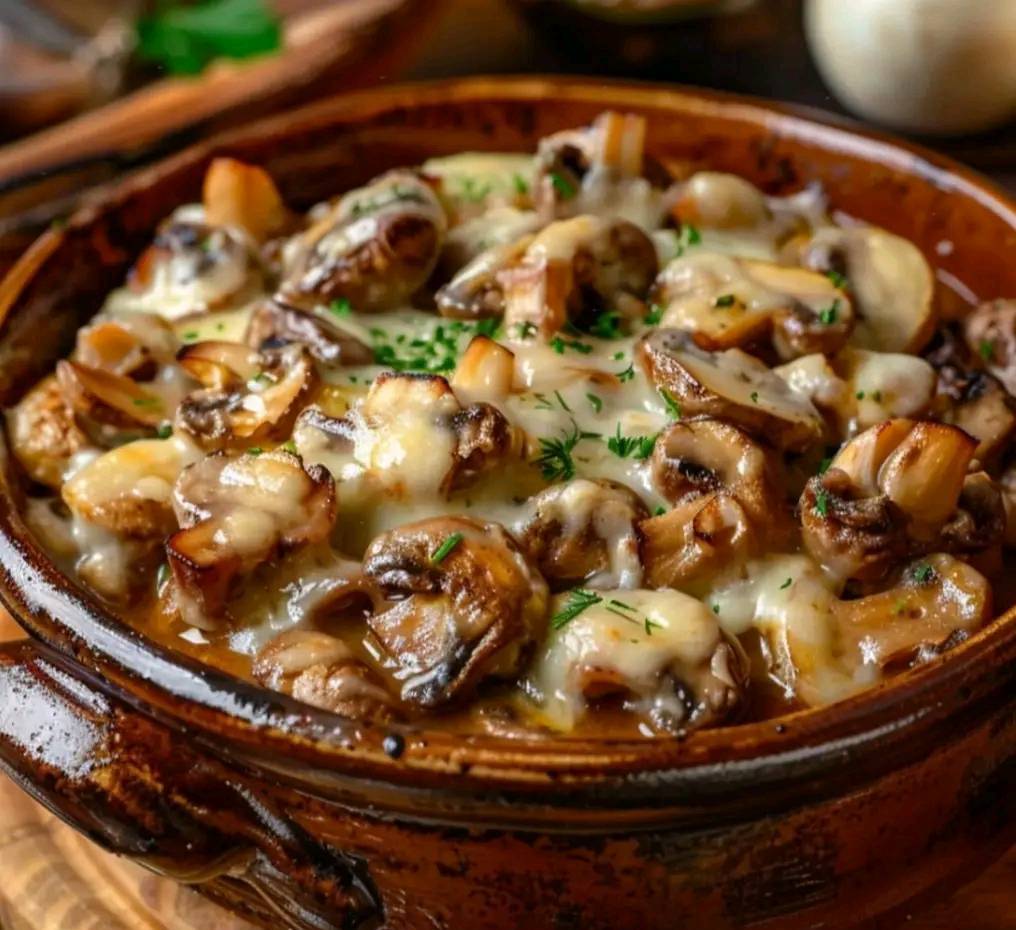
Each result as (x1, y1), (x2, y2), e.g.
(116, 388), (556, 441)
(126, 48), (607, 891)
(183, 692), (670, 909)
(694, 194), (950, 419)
(526, 590), (748, 736)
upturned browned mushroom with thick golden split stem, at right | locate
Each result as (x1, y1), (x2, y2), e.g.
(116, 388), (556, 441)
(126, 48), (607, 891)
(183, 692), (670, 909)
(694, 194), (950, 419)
(800, 419), (1004, 580)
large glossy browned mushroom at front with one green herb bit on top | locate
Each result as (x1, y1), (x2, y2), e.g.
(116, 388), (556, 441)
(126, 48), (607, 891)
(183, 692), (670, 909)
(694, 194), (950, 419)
(364, 517), (548, 707)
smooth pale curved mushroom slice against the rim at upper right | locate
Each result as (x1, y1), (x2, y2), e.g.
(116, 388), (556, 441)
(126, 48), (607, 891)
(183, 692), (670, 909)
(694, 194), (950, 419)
(800, 226), (937, 353)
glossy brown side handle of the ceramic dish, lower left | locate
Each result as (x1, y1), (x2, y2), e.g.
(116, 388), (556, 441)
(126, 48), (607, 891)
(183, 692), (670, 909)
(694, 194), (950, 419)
(0, 642), (381, 930)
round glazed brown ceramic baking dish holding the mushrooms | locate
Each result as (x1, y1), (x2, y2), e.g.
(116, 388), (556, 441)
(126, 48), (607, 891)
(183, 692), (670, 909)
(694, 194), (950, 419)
(0, 79), (1016, 930)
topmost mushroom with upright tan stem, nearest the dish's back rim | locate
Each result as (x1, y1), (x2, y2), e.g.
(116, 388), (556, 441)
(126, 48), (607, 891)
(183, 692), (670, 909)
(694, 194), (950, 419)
(532, 112), (645, 220)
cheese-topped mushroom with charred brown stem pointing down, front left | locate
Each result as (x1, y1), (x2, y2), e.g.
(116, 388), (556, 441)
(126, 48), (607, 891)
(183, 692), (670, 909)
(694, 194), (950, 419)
(166, 450), (335, 628)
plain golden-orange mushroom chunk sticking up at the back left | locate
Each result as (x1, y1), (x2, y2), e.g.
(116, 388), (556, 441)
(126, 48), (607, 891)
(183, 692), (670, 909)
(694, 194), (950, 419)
(201, 158), (289, 242)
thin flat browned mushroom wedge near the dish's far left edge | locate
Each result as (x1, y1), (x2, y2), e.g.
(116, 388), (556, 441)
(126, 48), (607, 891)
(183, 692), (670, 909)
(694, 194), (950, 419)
(57, 360), (172, 448)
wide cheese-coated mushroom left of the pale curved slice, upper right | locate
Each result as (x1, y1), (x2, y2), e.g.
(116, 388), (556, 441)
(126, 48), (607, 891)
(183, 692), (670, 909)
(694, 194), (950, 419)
(652, 250), (853, 359)
